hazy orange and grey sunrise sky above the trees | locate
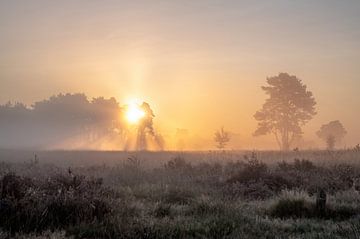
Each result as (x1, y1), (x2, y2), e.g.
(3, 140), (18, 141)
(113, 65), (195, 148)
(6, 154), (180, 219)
(0, 0), (360, 149)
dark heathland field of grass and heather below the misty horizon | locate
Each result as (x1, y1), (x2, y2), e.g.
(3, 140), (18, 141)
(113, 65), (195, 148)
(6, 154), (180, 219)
(0, 148), (360, 239)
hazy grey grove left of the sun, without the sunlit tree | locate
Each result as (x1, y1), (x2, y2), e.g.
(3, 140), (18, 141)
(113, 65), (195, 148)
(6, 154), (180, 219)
(0, 93), (125, 149)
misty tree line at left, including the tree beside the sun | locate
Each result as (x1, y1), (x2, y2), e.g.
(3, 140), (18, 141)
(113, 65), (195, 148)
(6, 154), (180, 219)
(0, 93), (163, 150)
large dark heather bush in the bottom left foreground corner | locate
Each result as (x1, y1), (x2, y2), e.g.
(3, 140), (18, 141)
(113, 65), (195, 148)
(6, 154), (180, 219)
(0, 174), (111, 234)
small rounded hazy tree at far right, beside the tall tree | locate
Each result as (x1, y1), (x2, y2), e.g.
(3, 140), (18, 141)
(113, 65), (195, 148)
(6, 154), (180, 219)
(316, 120), (347, 150)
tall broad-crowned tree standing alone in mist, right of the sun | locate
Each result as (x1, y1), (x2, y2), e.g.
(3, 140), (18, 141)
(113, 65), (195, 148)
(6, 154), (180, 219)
(254, 73), (316, 151)
